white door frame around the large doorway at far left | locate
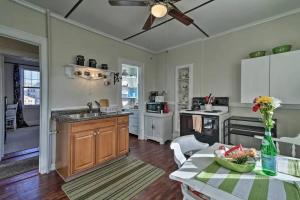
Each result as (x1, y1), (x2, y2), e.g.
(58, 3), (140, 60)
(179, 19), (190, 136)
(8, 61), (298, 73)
(0, 25), (51, 174)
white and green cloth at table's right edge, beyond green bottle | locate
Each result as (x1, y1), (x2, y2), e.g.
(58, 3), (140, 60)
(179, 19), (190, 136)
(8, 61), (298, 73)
(277, 156), (300, 177)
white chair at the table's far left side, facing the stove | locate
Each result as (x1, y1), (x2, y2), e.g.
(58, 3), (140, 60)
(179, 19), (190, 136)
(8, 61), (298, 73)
(170, 135), (209, 168)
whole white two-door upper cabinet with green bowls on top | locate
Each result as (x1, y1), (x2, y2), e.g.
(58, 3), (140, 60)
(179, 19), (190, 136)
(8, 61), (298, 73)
(241, 51), (300, 104)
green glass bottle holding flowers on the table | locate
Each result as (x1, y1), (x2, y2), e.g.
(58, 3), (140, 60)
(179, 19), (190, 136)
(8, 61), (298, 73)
(260, 129), (277, 176)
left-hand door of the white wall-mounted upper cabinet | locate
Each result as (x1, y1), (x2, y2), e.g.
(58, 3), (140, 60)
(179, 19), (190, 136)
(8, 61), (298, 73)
(241, 56), (270, 103)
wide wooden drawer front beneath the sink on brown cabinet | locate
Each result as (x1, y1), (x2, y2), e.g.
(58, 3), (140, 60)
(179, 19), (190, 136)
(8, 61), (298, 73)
(71, 118), (116, 132)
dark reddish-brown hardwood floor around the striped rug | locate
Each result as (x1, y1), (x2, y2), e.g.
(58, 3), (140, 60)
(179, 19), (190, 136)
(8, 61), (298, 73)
(0, 136), (182, 200)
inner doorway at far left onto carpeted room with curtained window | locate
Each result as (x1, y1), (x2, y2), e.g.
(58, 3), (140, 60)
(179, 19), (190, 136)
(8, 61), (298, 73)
(4, 54), (40, 158)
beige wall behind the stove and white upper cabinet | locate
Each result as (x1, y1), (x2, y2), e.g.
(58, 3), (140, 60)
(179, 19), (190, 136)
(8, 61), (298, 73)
(156, 13), (300, 144)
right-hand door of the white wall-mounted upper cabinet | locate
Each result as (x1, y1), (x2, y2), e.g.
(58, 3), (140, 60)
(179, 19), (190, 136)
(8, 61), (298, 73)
(270, 51), (300, 104)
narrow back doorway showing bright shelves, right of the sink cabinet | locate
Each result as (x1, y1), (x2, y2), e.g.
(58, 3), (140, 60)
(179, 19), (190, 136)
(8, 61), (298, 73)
(119, 59), (144, 139)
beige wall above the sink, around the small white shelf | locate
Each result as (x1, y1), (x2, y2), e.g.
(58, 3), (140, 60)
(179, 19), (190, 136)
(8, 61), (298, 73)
(0, 0), (156, 109)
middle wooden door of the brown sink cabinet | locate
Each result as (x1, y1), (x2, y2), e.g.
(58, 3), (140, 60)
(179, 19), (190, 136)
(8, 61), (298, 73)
(96, 126), (116, 164)
